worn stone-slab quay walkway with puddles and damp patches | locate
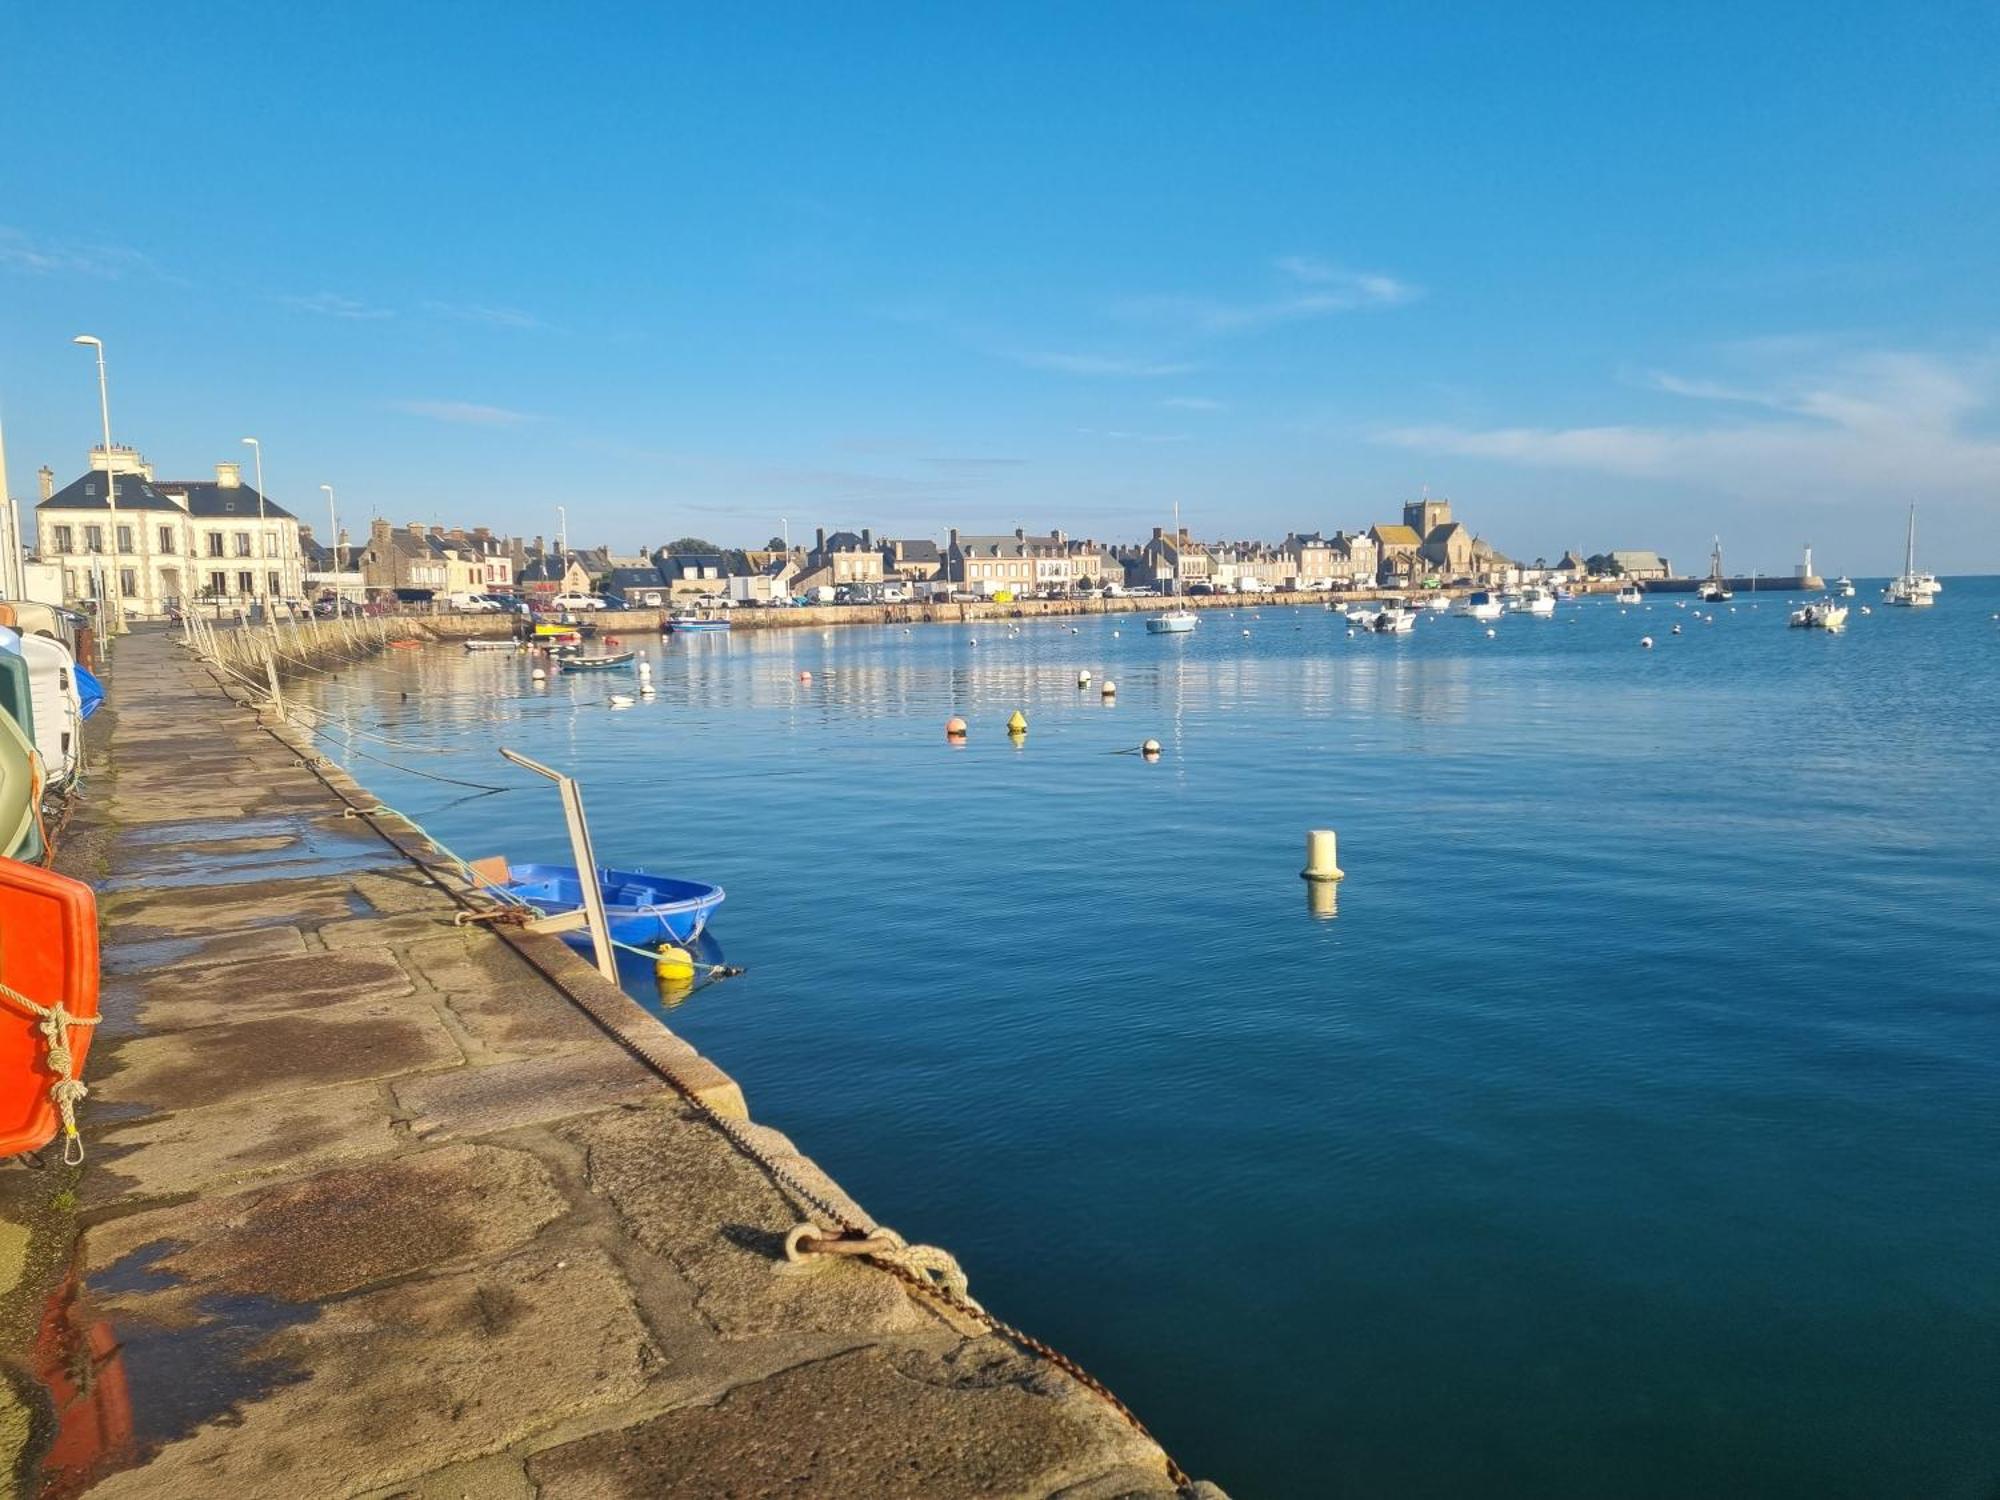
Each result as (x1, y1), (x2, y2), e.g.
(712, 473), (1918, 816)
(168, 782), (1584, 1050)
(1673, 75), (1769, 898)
(0, 634), (1220, 1500)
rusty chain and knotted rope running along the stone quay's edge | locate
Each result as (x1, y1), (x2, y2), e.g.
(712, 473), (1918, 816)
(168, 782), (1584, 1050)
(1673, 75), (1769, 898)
(213, 656), (1196, 1496)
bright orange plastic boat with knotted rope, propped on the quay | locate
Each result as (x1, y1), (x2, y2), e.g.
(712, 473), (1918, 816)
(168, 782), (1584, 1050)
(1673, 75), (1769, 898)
(0, 860), (98, 1156)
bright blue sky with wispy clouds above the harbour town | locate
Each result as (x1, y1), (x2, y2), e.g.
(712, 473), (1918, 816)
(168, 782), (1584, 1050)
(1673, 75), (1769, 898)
(0, 0), (2000, 572)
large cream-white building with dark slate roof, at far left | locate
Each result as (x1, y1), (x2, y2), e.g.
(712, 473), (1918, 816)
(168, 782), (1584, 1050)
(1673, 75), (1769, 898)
(34, 446), (306, 620)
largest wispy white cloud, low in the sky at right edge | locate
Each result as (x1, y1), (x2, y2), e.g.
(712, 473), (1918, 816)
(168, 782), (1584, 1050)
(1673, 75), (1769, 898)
(1378, 350), (2000, 498)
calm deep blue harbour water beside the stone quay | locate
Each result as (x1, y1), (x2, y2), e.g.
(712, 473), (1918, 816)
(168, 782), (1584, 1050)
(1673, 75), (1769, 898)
(304, 578), (2000, 1500)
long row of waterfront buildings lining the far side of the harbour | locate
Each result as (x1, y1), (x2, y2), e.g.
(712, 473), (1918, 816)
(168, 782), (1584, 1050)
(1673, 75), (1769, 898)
(15, 448), (1670, 616)
